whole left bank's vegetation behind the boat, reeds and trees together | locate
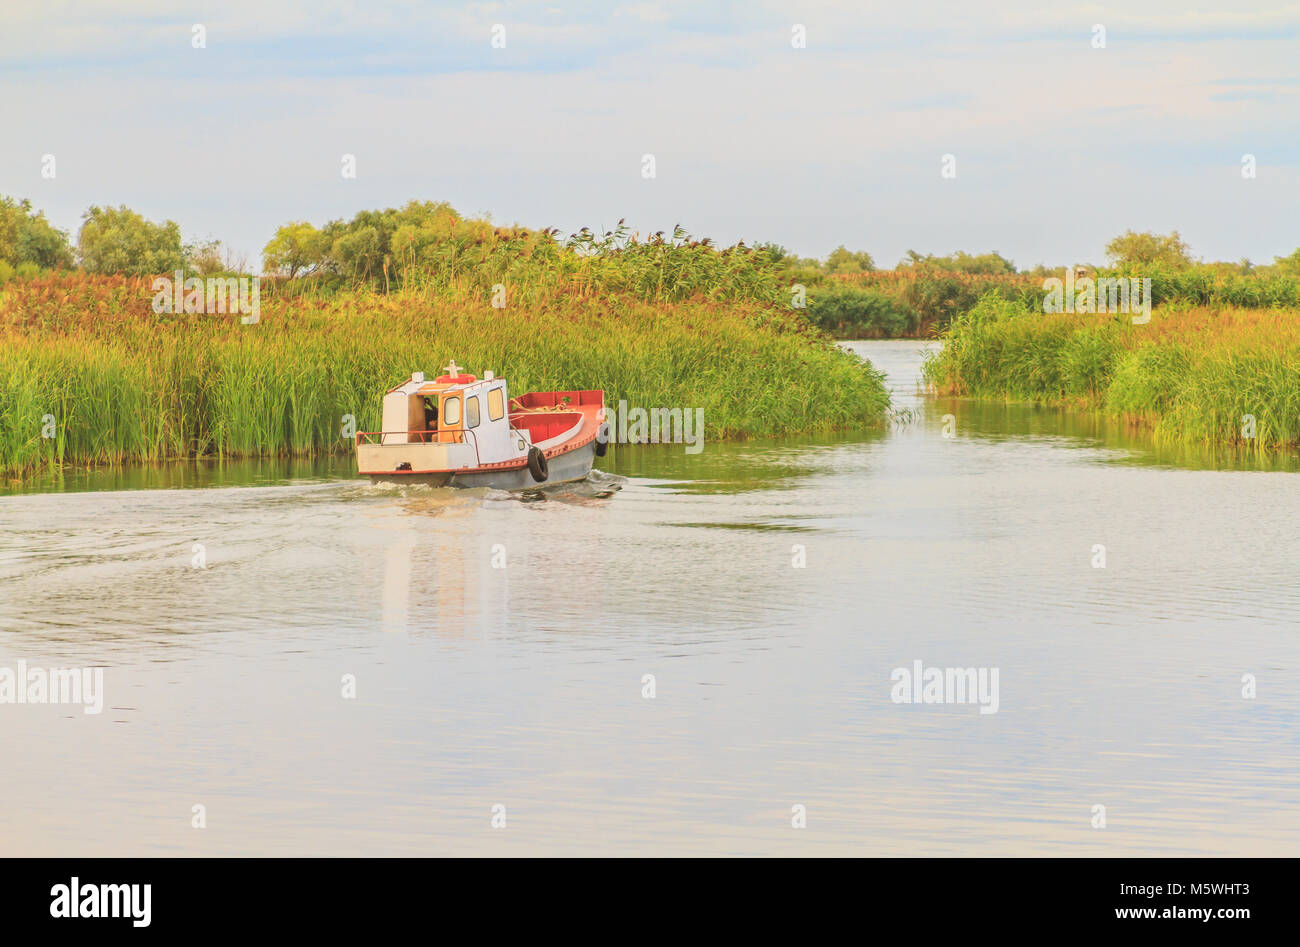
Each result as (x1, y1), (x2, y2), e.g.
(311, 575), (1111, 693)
(0, 202), (889, 475)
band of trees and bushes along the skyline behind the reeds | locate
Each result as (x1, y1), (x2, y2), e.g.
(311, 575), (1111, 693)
(0, 198), (1300, 338)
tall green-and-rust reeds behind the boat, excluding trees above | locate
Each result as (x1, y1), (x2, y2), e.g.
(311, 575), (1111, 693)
(0, 274), (888, 477)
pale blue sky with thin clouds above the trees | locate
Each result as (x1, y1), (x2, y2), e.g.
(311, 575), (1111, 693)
(0, 0), (1300, 269)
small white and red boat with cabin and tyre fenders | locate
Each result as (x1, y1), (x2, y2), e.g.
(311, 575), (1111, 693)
(356, 359), (608, 490)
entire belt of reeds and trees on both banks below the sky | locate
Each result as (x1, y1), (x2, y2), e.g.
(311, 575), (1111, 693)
(0, 188), (1300, 474)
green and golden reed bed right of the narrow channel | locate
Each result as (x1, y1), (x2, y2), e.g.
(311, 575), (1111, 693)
(924, 295), (1300, 449)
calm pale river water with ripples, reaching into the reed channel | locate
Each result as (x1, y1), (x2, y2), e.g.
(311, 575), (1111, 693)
(0, 342), (1300, 855)
